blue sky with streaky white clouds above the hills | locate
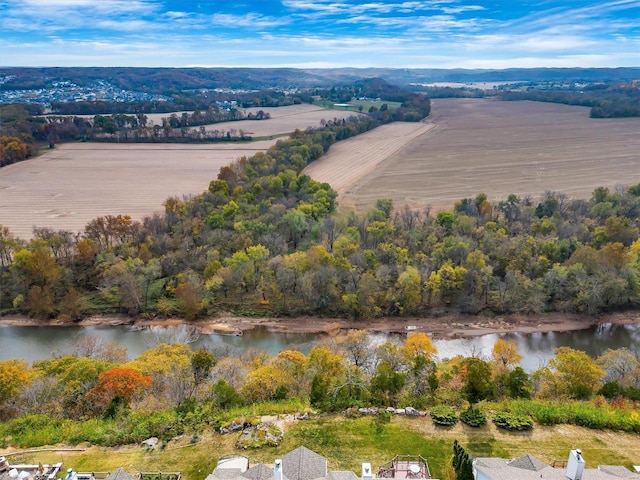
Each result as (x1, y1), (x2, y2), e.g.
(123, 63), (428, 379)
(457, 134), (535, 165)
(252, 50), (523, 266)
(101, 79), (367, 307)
(0, 0), (640, 68)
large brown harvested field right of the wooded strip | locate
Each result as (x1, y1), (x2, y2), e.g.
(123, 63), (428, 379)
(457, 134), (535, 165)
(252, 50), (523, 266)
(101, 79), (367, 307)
(309, 99), (640, 211)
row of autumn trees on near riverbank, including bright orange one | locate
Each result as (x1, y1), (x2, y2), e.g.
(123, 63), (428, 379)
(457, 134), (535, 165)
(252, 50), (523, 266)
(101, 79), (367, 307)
(0, 330), (640, 444)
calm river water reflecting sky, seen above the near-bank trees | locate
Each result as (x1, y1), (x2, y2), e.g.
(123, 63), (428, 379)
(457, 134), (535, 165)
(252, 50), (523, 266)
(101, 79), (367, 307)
(0, 324), (640, 372)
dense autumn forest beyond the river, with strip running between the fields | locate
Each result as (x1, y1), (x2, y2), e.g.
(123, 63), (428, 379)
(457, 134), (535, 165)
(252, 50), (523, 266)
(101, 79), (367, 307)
(0, 84), (640, 320)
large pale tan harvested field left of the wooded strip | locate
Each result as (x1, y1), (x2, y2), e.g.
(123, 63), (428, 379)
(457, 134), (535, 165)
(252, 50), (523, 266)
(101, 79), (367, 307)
(0, 141), (274, 239)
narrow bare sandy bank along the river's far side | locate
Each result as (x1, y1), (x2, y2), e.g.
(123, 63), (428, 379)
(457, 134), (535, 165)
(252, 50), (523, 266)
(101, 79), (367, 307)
(0, 312), (640, 339)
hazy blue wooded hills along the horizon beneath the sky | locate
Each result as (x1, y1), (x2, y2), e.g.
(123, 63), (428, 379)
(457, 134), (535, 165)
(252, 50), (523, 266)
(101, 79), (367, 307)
(0, 67), (640, 94)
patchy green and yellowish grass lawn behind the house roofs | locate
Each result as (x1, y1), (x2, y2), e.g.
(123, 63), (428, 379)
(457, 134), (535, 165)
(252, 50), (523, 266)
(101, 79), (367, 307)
(6, 415), (640, 480)
